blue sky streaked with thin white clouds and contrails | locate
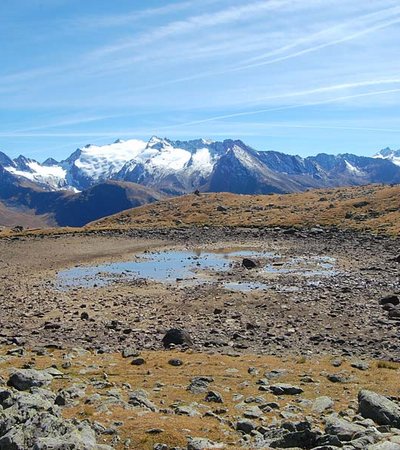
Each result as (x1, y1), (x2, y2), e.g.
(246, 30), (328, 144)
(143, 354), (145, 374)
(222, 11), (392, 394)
(0, 0), (400, 160)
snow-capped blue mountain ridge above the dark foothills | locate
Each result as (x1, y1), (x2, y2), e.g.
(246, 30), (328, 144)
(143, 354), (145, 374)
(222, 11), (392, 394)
(0, 136), (400, 195)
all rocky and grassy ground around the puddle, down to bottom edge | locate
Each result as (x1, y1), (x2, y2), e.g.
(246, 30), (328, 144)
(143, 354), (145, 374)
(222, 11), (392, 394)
(0, 227), (400, 450)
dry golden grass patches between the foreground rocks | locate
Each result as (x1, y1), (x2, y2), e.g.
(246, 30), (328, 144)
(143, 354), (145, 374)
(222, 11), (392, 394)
(0, 349), (400, 449)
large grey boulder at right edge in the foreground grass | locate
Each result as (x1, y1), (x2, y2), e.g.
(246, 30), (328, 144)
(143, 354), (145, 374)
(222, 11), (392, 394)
(358, 389), (400, 428)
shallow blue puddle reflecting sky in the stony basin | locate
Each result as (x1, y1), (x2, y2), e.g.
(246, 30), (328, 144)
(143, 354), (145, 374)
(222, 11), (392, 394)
(57, 250), (336, 292)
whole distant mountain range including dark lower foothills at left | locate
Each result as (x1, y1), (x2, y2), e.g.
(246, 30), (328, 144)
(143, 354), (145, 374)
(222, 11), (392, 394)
(0, 137), (400, 226)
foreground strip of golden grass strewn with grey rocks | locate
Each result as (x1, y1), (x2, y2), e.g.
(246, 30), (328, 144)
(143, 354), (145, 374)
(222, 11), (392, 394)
(0, 346), (400, 450)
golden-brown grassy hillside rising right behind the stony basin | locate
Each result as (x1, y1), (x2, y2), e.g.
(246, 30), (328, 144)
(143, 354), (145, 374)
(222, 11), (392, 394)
(89, 185), (400, 235)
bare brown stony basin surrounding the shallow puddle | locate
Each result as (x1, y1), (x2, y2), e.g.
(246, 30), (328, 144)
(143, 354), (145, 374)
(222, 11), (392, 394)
(0, 228), (400, 361)
